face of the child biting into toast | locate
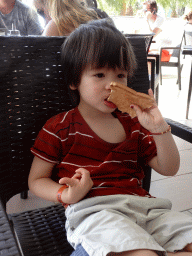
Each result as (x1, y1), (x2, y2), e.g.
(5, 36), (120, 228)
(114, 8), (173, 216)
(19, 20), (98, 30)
(71, 66), (127, 113)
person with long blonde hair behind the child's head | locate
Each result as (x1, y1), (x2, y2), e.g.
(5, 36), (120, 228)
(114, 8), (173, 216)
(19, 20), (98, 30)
(33, 0), (114, 36)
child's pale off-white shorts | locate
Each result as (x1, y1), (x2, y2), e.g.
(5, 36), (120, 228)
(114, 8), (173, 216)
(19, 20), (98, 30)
(66, 195), (192, 256)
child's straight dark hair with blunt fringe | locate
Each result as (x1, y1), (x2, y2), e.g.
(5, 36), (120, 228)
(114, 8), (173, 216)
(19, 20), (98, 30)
(61, 19), (137, 86)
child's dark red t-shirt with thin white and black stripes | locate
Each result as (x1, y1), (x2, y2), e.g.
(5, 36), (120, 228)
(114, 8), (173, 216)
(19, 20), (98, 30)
(31, 108), (157, 197)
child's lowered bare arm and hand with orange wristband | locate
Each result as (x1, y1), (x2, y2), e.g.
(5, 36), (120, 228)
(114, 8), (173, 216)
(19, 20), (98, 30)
(28, 157), (93, 204)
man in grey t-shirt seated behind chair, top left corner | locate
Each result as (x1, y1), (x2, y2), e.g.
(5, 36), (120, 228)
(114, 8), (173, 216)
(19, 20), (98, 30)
(0, 0), (43, 36)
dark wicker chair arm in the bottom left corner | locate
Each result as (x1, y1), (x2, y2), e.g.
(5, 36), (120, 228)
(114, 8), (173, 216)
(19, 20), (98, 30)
(0, 201), (21, 256)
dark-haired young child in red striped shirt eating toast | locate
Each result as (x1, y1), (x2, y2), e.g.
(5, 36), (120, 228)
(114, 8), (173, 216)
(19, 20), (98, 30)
(29, 20), (192, 256)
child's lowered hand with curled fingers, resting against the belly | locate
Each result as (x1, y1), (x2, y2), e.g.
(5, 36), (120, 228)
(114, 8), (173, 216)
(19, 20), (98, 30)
(59, 168), (93, 204)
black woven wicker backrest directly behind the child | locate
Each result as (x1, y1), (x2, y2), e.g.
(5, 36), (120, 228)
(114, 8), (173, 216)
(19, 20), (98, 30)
(0, 36), (149, 206)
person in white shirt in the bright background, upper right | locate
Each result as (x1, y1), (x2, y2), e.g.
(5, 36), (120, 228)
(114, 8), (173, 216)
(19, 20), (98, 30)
(144, 0), (164, 37)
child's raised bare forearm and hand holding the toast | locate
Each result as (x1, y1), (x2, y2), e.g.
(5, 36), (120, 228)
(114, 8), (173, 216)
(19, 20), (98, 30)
(131, 90), (180, 176)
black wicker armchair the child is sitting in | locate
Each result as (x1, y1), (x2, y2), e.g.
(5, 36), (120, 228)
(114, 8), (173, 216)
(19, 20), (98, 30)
(0, 36), (192, 256)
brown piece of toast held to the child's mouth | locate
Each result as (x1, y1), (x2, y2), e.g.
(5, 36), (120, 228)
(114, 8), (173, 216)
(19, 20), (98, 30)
(107, 82), (155, 118)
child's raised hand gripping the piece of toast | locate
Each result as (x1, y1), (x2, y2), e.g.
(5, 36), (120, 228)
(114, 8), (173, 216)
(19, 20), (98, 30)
(131, 89), (168, 133)
